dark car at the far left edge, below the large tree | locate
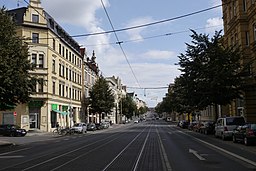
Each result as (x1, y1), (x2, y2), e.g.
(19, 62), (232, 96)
(0, 124), (27, 137)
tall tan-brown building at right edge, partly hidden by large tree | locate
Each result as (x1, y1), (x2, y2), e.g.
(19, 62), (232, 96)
(222, 0), (256, 122)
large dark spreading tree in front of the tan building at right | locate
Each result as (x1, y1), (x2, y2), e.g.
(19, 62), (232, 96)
(175, 30), (242, 119)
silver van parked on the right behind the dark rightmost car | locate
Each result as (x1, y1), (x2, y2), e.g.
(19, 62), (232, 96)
(215, 116), (245, 140)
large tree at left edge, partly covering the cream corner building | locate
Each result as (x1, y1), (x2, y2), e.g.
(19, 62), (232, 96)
(0, 8), (38, 110)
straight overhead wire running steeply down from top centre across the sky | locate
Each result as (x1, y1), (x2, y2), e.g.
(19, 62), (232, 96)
(101, 0), (141, 87)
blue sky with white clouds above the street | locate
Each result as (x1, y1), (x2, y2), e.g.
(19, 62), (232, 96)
(0, 0), (223, 107)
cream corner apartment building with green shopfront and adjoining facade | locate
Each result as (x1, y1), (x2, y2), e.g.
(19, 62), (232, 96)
(0, 0), (98, 131)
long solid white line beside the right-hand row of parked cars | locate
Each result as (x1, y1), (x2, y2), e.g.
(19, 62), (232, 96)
(181, 132), (256, 166)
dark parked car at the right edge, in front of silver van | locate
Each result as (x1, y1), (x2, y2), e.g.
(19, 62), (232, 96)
(233, 123), (256, 145)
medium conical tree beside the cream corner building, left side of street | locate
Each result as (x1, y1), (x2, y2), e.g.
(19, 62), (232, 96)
(89, 76), (115, 119)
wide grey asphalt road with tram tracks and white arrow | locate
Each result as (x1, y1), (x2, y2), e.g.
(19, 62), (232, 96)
(0, 120), (256, 171)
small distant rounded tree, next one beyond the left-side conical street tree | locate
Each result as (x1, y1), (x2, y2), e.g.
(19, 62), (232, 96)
(121, 96), (137, 118)
